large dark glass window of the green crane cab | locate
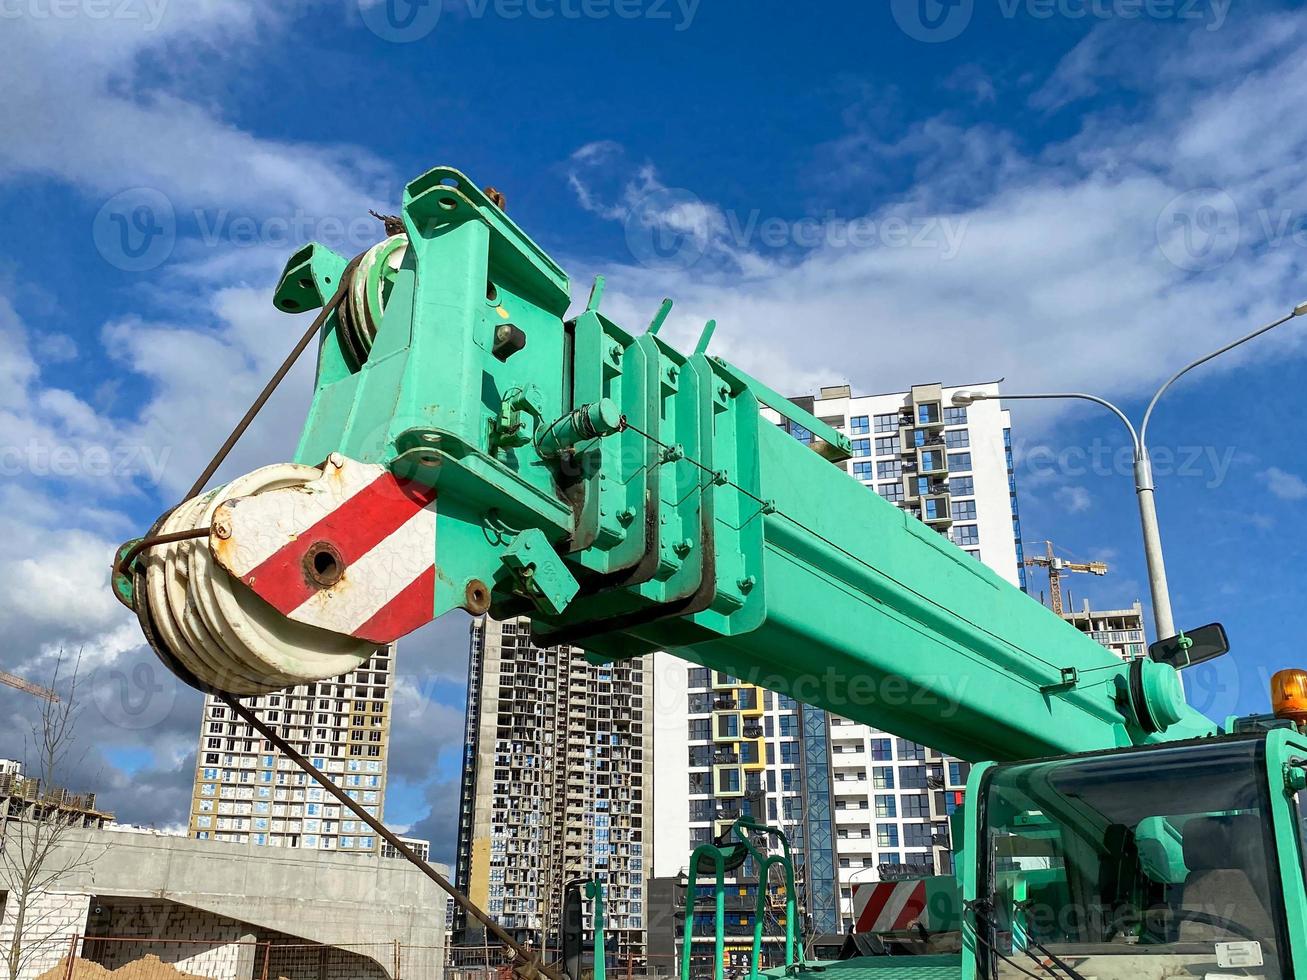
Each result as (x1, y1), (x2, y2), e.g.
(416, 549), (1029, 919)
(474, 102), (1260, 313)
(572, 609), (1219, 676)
(976, 738), (1300, 980)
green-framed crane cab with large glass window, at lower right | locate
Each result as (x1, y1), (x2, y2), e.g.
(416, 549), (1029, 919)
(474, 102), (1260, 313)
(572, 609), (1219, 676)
(958, 728), (1307, 980)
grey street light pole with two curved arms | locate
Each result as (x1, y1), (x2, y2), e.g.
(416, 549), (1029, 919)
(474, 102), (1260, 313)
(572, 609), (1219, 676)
(953, 302), (1307, 640)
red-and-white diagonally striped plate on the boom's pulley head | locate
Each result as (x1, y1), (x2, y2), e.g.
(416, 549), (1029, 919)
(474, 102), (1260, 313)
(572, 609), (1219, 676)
(210, 453), (435, 643)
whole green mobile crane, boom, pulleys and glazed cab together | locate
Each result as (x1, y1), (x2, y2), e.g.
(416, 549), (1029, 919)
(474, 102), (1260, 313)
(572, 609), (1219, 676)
(114, 167), (1307, 980)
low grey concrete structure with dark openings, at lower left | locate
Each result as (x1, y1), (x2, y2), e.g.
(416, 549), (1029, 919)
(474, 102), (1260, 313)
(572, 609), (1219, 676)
(0, 830), (446, 980)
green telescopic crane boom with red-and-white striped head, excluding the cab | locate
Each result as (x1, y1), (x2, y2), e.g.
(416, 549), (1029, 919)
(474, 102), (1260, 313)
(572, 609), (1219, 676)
(120, 169), (1214, 759)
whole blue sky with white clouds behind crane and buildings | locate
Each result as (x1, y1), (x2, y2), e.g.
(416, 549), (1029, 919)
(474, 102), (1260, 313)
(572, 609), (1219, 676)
(0, 0), (1307, 857)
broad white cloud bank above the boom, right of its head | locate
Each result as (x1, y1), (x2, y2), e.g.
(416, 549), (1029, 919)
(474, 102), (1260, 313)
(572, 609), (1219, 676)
(571, 14), (1307, 415)
